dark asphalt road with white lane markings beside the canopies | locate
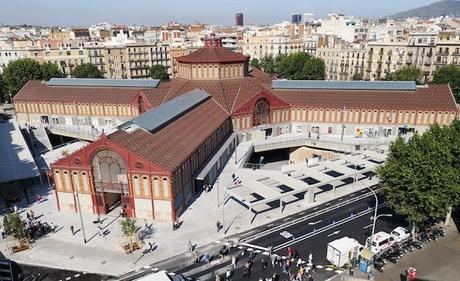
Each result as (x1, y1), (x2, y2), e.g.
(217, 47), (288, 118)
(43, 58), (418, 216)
(181, 186), (407, 280)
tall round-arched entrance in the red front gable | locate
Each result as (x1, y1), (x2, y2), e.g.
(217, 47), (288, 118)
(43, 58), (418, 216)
(91, 149), (131, 214)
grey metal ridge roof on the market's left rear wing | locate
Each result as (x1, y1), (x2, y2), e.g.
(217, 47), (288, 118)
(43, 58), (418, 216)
(45, 78), (160, 88)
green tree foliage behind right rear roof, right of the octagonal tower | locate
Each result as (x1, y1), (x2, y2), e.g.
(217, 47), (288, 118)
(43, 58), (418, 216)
(276, 53), (326, 80)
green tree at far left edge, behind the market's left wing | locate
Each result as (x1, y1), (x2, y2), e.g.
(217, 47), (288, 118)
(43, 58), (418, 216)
(3, 58), (42, 96)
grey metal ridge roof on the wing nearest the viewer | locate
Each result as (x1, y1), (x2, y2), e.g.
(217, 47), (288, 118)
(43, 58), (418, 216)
(118, 89), (211, 133)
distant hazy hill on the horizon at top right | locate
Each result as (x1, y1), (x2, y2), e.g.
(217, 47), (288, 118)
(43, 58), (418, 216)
(389, 0), (460, 19)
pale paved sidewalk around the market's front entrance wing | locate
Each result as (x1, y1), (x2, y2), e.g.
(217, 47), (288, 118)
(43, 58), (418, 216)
(0, 145), (378, 276)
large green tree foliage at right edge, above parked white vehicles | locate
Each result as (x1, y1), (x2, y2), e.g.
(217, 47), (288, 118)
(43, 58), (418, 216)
(377, 120), (460, 226)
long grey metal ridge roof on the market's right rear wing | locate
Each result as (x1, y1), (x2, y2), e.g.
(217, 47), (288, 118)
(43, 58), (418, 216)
(272, 80), (417, 91)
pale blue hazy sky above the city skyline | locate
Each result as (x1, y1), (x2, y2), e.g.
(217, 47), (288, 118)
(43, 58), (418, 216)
(0, 0), (436, 26)
